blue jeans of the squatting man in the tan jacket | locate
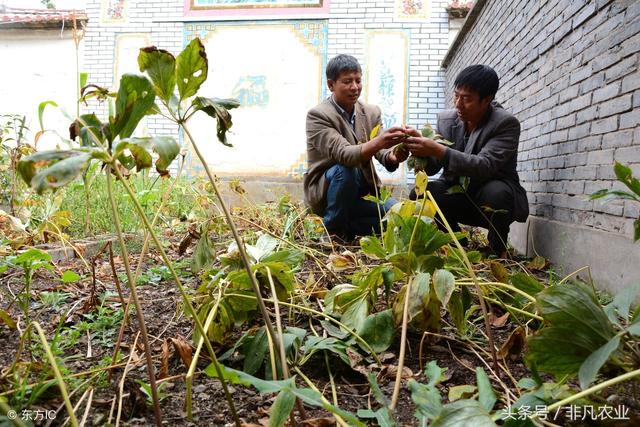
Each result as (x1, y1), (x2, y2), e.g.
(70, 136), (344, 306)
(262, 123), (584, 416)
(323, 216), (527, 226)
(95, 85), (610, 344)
(323, 165), (396, 238)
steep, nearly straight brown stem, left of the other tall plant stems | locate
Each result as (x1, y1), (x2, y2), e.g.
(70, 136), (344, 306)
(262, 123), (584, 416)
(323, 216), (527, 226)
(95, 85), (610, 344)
(106, 165), (162, 427)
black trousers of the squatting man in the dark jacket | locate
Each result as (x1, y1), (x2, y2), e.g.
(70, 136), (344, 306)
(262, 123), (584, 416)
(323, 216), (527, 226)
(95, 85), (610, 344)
(411, 179), (514, 254)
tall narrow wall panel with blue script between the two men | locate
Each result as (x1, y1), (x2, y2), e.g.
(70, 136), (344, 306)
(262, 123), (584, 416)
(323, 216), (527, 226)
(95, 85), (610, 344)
(365, 30), (409, 182)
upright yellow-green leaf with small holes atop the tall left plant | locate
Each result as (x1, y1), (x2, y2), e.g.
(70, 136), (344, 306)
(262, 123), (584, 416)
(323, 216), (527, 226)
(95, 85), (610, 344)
(176, 38), (209, 100)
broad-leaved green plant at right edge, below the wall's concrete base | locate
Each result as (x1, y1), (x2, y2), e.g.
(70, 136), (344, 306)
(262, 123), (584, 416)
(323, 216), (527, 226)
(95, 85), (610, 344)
(526, 282), (640, 389)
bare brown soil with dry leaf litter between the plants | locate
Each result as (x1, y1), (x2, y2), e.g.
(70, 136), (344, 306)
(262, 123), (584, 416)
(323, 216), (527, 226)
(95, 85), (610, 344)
(0, 236), (640, 426)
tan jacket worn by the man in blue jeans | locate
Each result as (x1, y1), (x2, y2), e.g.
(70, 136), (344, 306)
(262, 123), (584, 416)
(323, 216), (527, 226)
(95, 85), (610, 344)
(304, 98), (397, 215)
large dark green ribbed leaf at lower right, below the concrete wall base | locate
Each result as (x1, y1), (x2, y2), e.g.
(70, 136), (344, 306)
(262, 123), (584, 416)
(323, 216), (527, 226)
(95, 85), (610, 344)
(526, 283), (614, 378)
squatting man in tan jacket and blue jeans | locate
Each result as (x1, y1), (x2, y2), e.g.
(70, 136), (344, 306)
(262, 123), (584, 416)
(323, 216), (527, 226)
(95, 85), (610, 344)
(304, 55), (408, 239)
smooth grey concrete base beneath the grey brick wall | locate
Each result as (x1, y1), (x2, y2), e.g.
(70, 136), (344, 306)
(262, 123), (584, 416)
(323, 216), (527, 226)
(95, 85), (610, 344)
(509, 216), (640, 294)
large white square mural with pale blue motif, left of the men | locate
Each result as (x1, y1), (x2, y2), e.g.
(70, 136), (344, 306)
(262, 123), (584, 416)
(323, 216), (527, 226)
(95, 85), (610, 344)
(185, 20), (327, 177)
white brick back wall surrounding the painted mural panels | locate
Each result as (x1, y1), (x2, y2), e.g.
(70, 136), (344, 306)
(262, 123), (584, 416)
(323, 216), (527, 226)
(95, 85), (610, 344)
(84, 0), (449, 177)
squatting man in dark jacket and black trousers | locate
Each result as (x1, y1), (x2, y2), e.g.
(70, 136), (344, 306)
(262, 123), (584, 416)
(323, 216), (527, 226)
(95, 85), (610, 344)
(406, 65), (529, 256)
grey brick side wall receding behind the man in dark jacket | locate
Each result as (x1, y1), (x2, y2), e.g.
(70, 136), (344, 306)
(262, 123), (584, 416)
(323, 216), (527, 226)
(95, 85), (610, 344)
(445, 0), (640, 236)
